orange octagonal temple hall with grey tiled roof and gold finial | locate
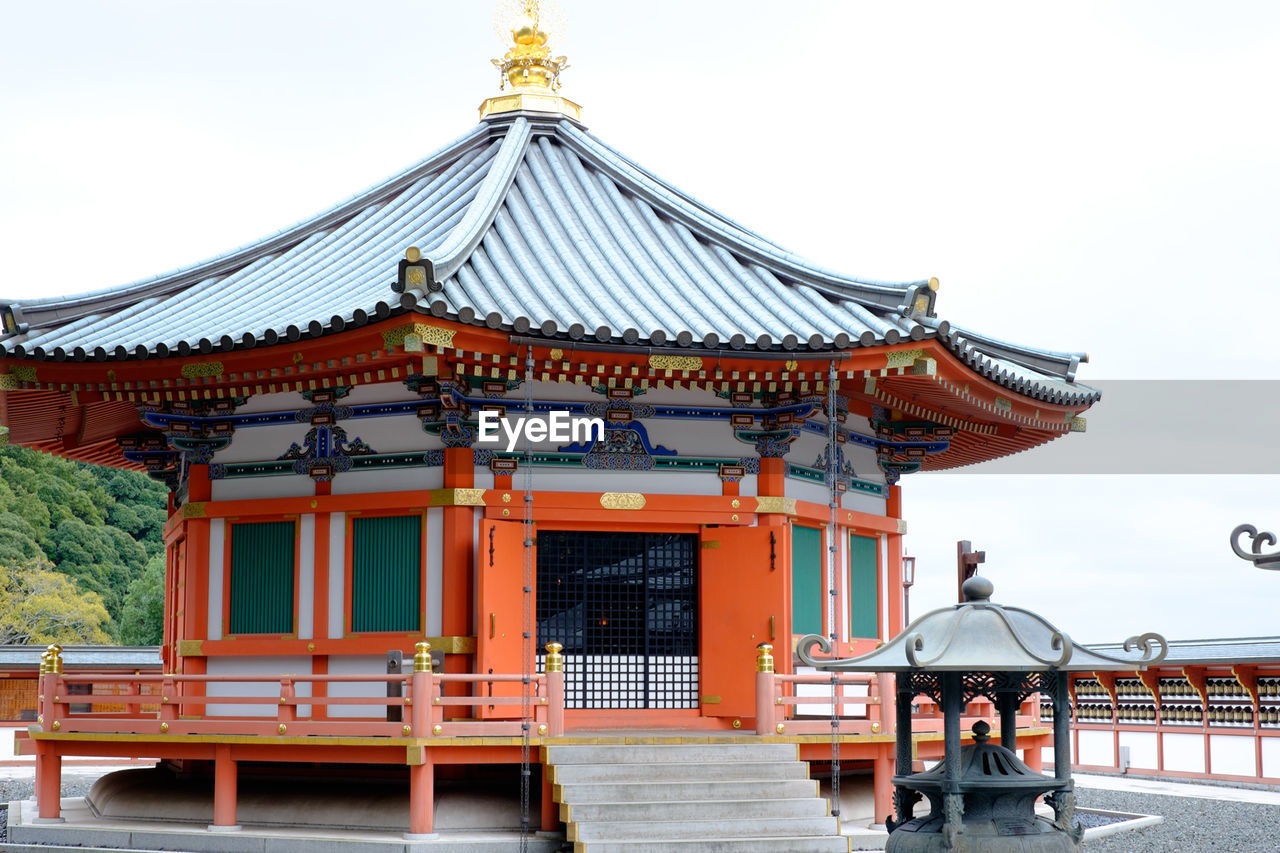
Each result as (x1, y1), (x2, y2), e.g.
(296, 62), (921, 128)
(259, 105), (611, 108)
(0, 4), (1098, 844)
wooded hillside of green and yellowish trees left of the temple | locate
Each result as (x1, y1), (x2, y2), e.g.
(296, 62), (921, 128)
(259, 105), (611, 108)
(0, 447), (168, 646)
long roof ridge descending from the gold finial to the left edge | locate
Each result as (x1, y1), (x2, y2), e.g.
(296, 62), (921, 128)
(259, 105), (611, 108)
(0, 124), (490, 327)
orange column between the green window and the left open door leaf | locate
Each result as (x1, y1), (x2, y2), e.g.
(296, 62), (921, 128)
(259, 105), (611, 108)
(442, 447), (476, 695)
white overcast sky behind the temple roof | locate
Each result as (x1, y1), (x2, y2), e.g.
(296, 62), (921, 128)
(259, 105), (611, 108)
(0, 0), (1280, 642)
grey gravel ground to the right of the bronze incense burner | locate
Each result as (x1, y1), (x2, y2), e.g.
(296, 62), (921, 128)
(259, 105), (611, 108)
(1075, 788), (1280, 853)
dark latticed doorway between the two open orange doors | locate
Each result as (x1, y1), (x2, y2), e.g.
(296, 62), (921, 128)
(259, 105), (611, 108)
(538, 530), (698, 708)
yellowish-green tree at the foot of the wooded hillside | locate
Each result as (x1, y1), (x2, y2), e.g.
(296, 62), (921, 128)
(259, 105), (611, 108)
(0, 558), (111, 646)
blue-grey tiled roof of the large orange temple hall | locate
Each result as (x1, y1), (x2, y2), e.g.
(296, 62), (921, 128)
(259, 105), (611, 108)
(0, 114), (1097, 403)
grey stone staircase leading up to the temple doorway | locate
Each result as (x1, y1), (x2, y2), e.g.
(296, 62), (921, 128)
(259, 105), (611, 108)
(544, 743), (850, 853)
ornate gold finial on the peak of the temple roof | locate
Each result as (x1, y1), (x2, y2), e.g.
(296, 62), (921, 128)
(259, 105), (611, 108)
(480, 0), (582, 119)
